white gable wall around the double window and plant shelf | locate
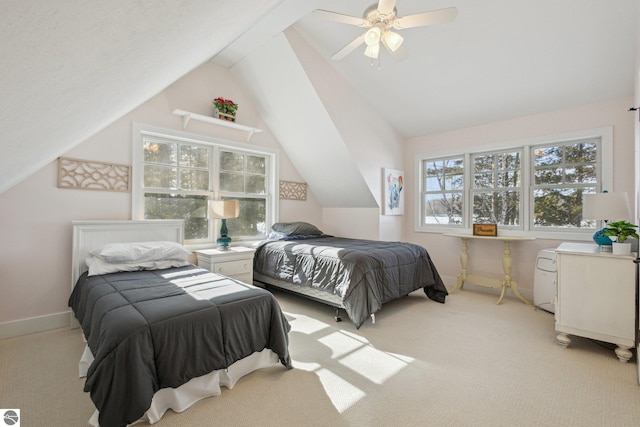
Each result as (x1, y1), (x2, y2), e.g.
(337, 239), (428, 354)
(0, 63), (322, 338)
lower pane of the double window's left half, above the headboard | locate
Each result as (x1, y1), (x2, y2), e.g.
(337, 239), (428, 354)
(144, 193), (209, 240)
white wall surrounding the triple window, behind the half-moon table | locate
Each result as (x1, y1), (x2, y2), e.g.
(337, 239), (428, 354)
(404, 97), (637, 299)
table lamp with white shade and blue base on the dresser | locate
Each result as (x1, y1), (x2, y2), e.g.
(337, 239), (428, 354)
(582, 191), (631, 252)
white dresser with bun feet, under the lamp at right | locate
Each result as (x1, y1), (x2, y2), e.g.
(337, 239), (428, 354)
(555, 243), (636, 362)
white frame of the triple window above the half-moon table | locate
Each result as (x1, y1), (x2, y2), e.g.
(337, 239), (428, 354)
(414, 126), (614, 241)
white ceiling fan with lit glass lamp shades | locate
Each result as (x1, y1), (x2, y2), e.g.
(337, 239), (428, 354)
(313, 0), (458, 60)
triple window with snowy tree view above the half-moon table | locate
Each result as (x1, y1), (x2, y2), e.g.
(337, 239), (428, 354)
(416, 128), (612, 239)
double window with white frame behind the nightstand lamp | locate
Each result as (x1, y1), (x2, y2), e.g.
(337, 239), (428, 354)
(132, 126), (277, 244)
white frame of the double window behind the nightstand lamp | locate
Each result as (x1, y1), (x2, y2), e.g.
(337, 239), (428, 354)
(131, 123), (279, 249)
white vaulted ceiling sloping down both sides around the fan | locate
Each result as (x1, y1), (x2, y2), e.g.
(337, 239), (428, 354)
(0, 0), (638, 193)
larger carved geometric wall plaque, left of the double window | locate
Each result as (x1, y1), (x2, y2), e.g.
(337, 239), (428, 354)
(58, 157), (131, 192)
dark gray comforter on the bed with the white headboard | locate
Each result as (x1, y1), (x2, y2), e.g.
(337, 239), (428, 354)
(69, 266), (291, 427)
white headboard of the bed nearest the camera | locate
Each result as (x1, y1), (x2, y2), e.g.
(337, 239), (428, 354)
(71, 220), (184, 289)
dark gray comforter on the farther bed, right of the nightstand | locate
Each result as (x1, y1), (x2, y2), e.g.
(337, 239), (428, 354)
(254, 236), (447, 328)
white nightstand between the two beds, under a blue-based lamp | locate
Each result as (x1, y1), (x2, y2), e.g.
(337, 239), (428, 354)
(196, 246), (255, 284)
